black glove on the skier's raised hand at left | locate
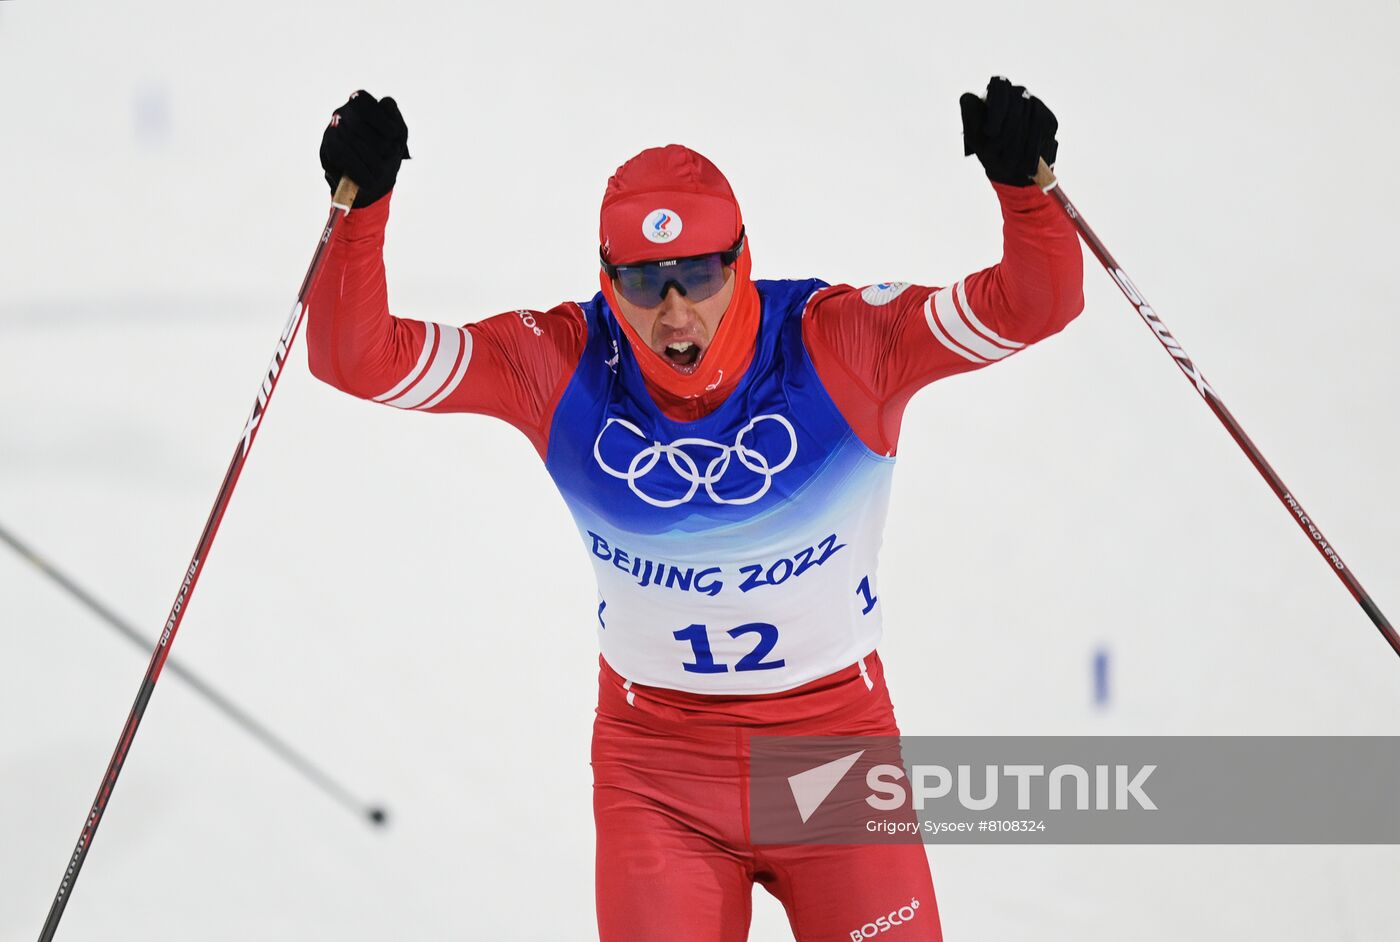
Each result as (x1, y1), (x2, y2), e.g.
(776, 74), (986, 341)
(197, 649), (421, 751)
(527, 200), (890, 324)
(321, 90), (409, 209)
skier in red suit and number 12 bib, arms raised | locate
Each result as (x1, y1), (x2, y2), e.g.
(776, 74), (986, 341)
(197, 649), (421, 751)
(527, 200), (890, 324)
(308, 78), (1084, 942)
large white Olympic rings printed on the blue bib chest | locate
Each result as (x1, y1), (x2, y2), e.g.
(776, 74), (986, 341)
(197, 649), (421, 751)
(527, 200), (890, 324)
(594, 414), (797, 507)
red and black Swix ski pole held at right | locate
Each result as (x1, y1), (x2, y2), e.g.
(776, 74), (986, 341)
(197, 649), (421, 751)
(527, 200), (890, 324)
(1036, 160), (1400, 655)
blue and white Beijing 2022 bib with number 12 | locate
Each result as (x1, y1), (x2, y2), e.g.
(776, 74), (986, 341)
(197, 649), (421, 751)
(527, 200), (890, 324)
(546, 280), (893, 693)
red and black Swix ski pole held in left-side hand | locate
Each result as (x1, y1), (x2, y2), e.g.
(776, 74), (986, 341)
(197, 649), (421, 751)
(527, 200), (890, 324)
(39, 176), (358, 942)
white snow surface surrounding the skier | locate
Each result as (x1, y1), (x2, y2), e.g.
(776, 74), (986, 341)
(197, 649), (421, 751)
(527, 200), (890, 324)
(0, 0), (1400, 942)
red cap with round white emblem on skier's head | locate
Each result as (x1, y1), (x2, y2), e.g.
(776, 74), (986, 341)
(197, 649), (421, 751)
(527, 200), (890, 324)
(598, 144), (743, 265)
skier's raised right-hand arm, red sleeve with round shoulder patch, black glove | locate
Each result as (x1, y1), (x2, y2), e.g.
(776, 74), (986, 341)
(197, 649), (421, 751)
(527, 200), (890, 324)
(804, 78), (1084, 454)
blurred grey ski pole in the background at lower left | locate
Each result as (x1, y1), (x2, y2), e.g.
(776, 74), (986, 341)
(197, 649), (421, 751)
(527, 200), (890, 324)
(0, 525), (388, 824)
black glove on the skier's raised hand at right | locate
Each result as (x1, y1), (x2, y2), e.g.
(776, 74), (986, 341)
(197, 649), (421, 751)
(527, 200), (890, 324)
(958, 76), (1060, 186)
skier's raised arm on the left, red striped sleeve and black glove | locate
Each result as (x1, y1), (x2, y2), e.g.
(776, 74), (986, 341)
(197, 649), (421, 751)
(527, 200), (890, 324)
(307, 91), (585, 455)
